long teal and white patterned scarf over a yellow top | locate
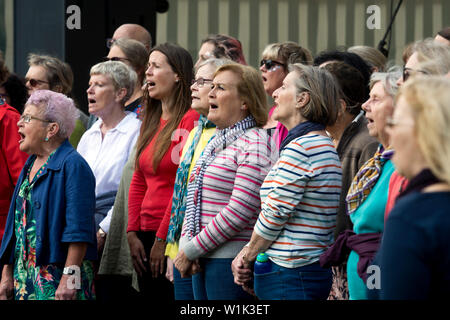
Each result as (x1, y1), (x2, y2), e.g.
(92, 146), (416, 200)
(166, 115), (215, 243)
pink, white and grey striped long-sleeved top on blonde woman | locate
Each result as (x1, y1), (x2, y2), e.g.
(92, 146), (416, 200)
(180, 128), (277, 260)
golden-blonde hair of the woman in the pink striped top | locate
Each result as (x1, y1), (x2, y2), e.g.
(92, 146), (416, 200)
(214, 62), (269, 127)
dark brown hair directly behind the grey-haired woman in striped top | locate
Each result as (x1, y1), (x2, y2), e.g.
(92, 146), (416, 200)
(324, 61), (366, 116)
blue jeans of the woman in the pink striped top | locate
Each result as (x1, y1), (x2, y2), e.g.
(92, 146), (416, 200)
(192, 258), (253, 300)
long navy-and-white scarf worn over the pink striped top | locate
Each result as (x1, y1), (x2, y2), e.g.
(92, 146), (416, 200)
(185, 115), (256, 240)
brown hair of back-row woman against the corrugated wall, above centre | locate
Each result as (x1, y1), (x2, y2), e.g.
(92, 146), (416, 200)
(202, 34), (247, 65)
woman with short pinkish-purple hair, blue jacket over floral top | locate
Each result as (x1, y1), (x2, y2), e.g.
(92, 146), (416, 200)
(0, 90), (97, 300)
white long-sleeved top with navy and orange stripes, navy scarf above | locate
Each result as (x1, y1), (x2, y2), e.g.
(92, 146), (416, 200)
(255, 134), (342, 268)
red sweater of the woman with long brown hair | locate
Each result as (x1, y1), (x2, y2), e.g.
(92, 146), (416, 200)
(127, 109), (199, 231)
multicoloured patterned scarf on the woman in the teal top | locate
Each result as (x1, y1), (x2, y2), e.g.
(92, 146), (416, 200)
(345, 144), (394, 215)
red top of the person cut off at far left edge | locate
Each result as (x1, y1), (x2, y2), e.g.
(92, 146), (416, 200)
(0, 103), (28, 243)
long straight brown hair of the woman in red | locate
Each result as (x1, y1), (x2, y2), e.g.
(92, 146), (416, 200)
(135, 43), (194, 172)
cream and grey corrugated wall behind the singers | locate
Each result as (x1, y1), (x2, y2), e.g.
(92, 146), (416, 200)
(157, 0), (450, 66)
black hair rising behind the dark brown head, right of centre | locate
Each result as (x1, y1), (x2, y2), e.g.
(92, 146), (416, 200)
(314, 50), (372, 100)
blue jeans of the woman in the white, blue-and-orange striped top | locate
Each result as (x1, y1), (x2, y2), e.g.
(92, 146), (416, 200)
(254, 260), (333, 300)
